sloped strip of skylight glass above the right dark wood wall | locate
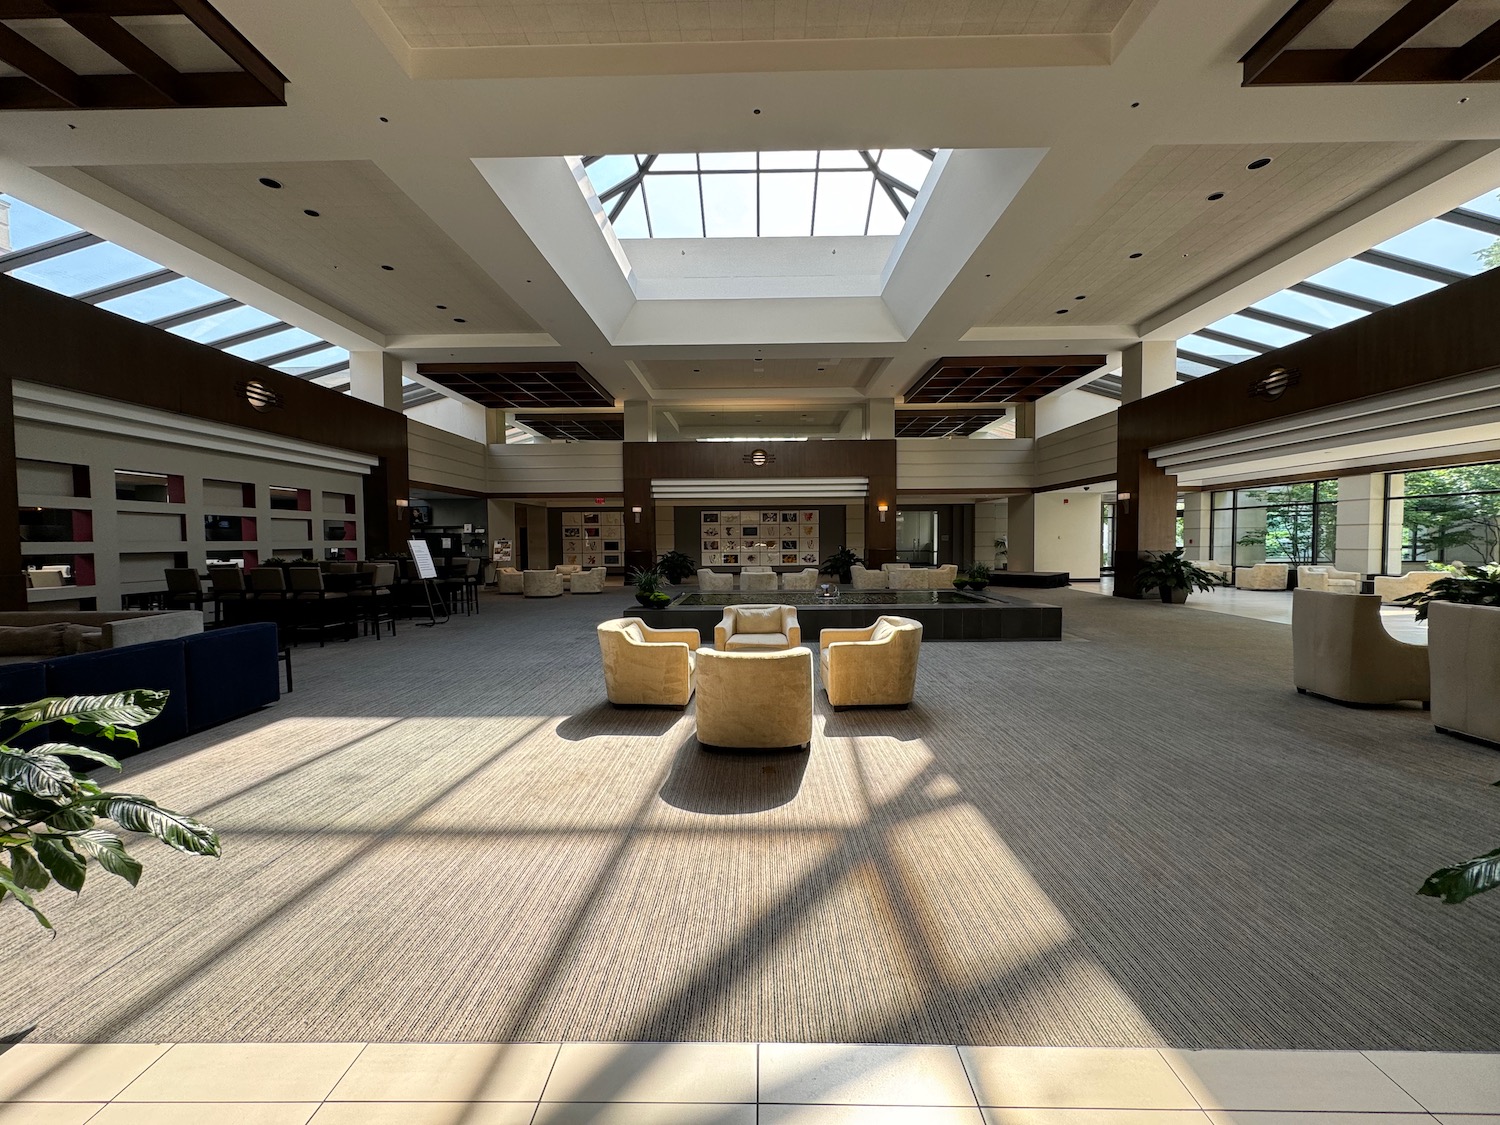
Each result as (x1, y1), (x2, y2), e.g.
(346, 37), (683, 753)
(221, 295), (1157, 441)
(1178, 191), (1500, 378)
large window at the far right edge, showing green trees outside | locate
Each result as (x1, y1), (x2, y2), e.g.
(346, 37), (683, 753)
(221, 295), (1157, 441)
(1386, 464), (1500, 573)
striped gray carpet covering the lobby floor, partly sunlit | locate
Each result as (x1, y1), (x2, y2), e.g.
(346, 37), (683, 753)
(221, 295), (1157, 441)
(0, 591), (1500, 1050)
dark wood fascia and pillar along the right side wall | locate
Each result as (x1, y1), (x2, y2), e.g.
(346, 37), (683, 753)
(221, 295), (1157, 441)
(1115, 270), (1500, 597)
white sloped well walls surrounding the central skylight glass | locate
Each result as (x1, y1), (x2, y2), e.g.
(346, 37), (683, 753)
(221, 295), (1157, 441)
(474, 149), (1046, 347)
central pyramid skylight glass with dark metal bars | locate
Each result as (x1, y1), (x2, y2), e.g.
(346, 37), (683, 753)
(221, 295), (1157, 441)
(582, 149), (938, 239)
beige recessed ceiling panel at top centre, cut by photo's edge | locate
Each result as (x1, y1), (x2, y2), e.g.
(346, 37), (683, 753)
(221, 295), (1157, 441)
(380, 0), (1130, 47)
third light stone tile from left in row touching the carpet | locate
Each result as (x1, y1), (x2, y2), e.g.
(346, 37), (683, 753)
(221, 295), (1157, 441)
(329, 1043), (558, 1101)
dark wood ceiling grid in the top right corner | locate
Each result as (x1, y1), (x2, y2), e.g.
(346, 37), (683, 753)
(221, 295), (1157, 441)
(1239, 0), (1500, 86)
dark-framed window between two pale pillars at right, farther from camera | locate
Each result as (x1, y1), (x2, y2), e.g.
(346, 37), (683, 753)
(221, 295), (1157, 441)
(1209, 480), (1338, 567)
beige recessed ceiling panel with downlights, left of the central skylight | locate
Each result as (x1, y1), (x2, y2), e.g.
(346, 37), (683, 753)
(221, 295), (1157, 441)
(84, 161), (537, 335)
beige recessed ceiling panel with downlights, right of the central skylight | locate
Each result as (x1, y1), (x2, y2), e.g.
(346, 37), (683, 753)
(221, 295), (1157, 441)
(990, 143), (1442, 327)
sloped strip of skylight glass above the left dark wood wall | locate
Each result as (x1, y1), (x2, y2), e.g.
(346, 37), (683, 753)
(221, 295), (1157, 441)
(0, 195), (350, 389)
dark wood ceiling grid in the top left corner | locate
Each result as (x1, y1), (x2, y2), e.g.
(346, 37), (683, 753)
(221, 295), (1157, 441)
(0, 0), (287, 110)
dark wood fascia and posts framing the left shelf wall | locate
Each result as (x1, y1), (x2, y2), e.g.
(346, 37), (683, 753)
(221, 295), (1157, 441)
(0, 276), (410, 609)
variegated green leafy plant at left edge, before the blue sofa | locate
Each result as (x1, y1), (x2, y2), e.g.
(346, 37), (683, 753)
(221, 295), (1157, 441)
(0, 692), (219, 930)
